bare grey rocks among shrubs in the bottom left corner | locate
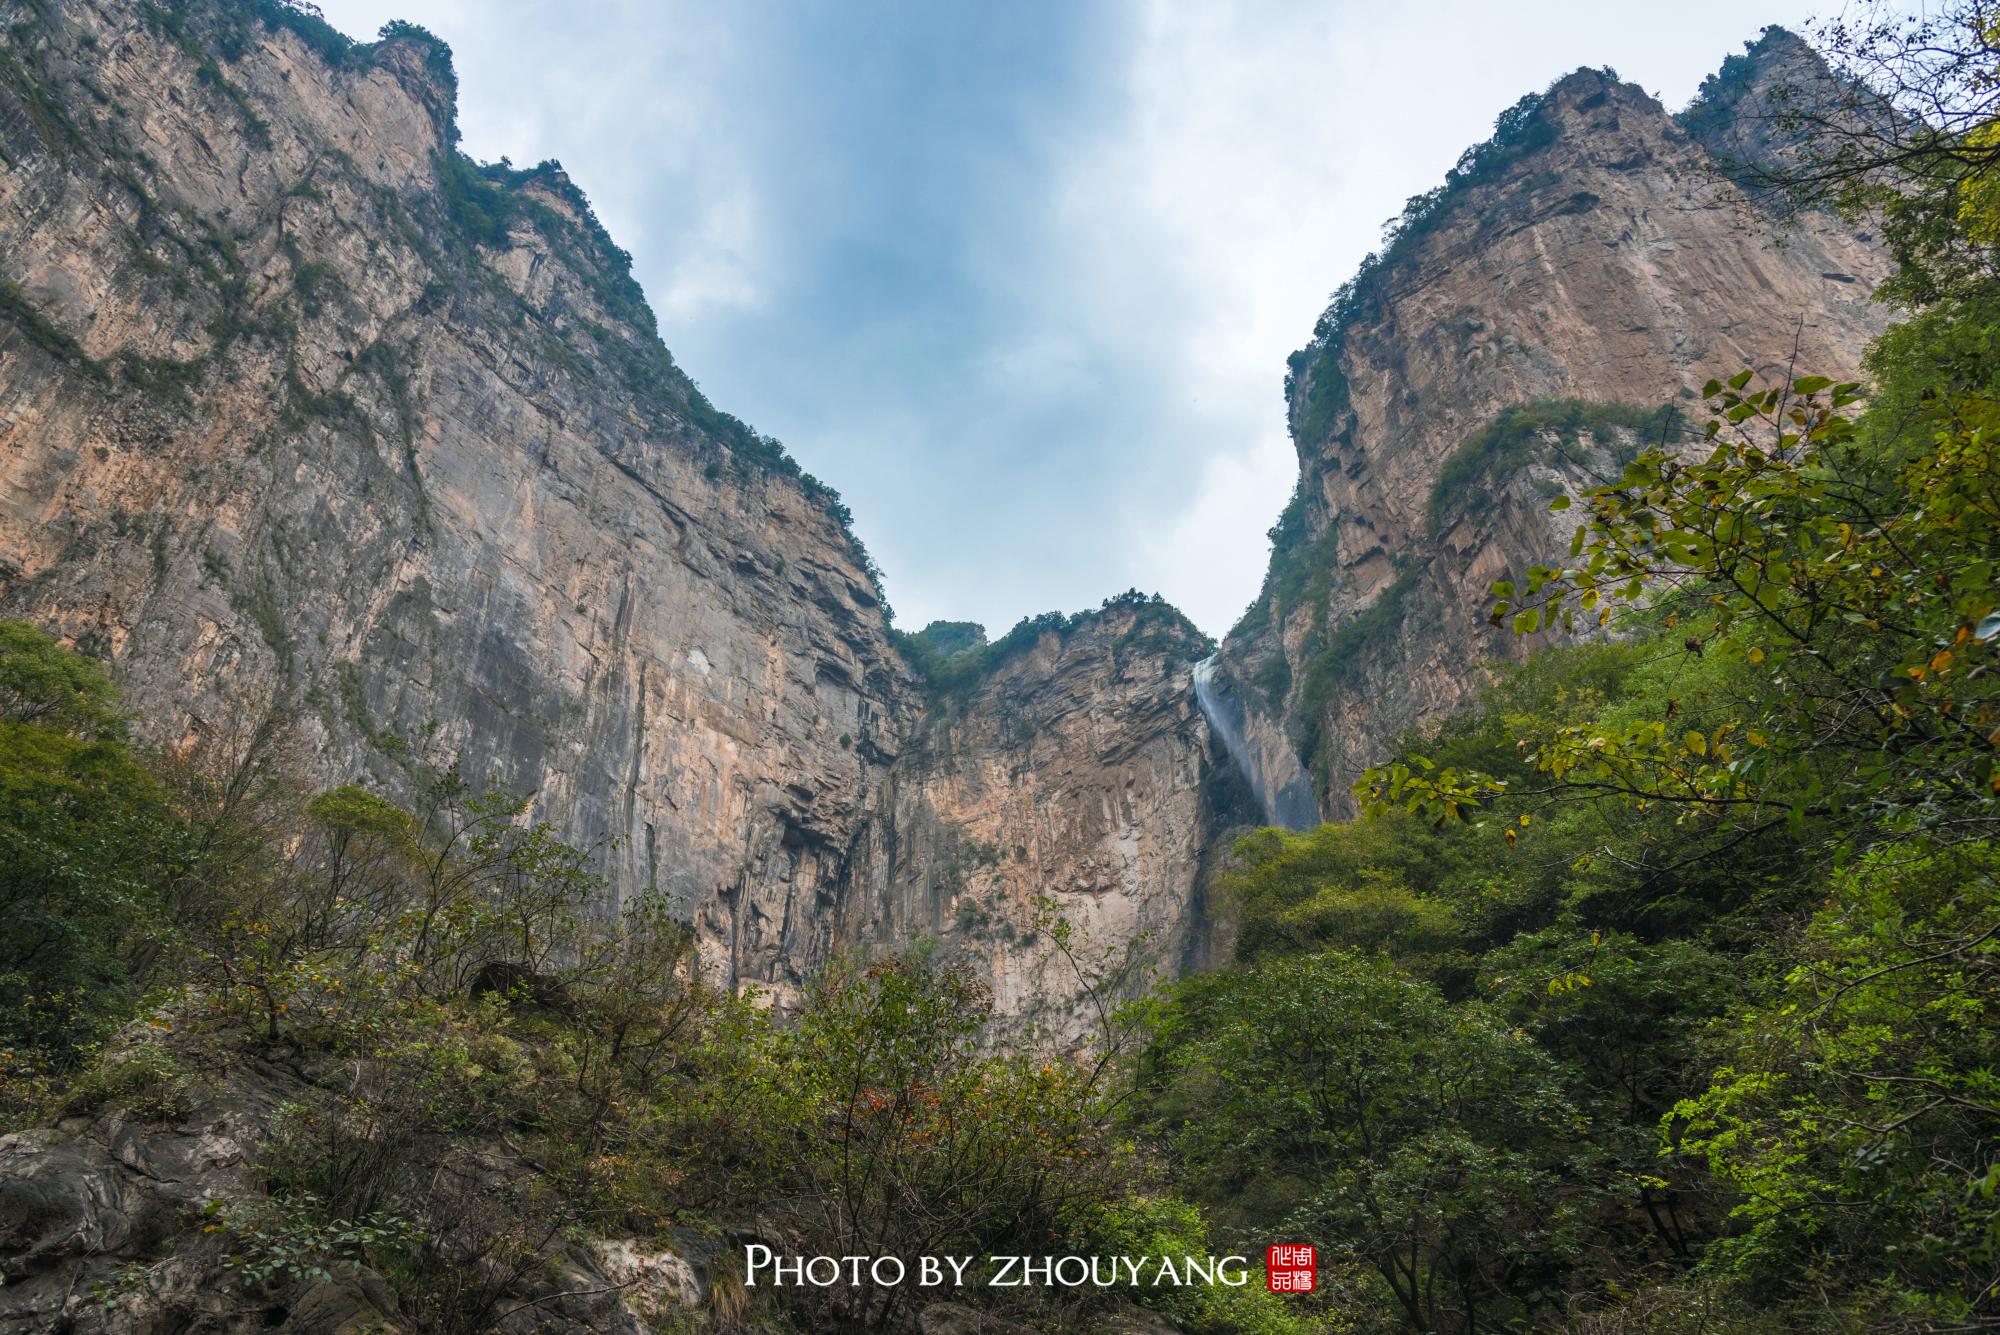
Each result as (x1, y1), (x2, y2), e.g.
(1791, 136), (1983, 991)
(0, 1045), (726, 1335)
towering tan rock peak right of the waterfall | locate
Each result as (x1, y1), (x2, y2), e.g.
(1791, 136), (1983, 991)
(1224, 57), (1890, 813)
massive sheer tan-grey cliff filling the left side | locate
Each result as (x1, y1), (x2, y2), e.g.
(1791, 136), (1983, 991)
(0, 0), (1200, 1031)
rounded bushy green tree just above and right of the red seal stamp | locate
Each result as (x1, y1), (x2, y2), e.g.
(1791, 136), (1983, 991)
(1160, 949), (1606, 1331)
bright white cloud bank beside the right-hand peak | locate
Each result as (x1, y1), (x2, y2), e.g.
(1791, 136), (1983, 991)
(1042, 0), (1832, 634)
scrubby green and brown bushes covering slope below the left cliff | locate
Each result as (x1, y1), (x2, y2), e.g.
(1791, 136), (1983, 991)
(0, 627), (1308, 1335)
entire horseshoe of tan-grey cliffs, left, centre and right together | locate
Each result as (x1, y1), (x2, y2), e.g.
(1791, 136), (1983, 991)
(0, 0), (1886, 1037)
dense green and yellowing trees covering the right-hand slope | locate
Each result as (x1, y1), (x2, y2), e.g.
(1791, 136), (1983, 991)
(1140, 18), (2000, 1331)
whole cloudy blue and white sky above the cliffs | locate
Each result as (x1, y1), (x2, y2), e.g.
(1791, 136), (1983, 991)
(322, 0), (1824, 636)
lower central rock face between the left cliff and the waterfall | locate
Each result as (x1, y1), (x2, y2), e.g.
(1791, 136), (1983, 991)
(842, 604), (1212, 1037)
